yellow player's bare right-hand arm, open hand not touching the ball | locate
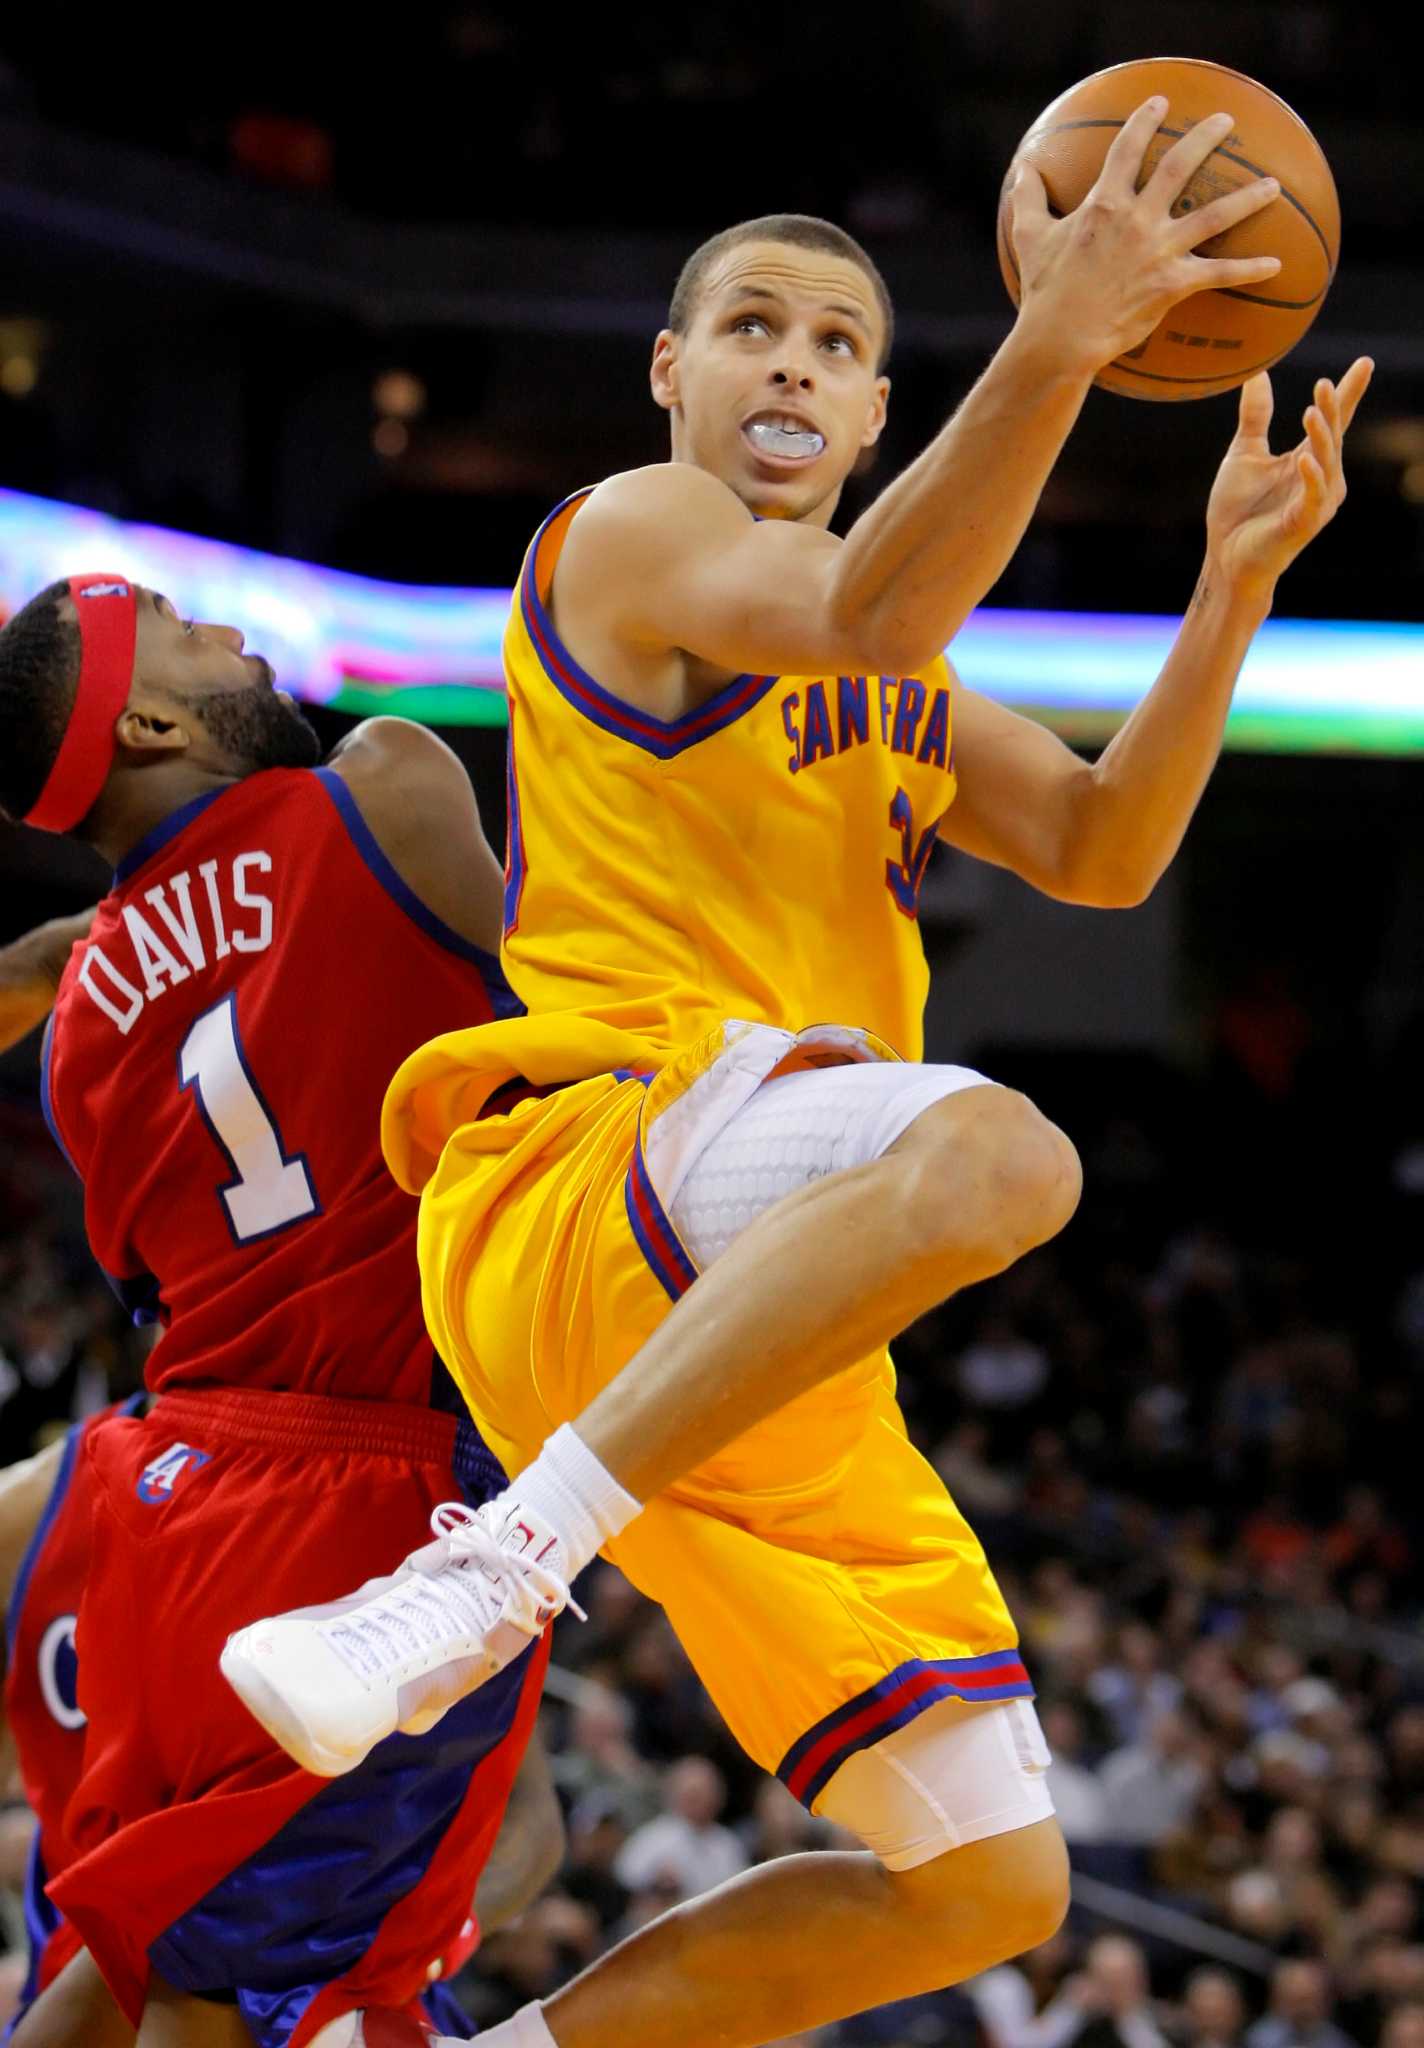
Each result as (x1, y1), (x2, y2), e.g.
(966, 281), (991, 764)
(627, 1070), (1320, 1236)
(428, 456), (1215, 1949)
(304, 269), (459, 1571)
(940, 358), (1373, 907)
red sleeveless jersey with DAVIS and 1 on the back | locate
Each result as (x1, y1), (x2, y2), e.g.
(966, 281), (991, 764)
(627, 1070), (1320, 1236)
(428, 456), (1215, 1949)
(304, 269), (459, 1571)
(43, 768), (520, 1403)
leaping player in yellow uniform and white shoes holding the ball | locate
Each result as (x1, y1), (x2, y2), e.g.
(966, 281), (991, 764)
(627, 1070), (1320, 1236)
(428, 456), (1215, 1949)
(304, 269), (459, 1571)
(225, 102), (1369, 2048)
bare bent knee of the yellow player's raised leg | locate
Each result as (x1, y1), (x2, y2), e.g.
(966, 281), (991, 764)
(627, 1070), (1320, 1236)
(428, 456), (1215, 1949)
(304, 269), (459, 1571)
(912, 1087), (1082, 1266)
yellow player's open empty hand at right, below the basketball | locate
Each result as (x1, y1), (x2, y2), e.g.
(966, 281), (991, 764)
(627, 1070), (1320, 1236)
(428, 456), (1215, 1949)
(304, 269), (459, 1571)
(1207, 356), (1375, 598)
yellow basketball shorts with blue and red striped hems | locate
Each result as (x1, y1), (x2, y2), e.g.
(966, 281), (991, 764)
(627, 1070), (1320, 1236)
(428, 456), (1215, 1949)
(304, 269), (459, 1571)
(420, 1024), (1033, 1806)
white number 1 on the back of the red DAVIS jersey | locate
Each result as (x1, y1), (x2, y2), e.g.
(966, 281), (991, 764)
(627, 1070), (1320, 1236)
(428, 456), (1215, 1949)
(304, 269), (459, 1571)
(178, 995), (322, 1245)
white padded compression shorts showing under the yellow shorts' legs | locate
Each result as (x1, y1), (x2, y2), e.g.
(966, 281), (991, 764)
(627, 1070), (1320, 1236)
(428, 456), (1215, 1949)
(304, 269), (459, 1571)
(672, 1061), (1053, 1870)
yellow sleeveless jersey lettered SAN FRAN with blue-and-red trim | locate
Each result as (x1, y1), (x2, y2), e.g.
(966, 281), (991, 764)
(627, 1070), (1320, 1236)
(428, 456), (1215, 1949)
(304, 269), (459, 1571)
(504, 492), (955, 1059)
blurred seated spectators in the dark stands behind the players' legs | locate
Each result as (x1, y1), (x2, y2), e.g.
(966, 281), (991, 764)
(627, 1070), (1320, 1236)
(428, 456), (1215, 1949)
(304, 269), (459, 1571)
(0, 1011), (1424, 2048)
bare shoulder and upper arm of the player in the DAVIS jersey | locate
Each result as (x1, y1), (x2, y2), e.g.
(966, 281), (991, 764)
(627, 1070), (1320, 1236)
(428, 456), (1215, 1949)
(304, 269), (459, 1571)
(328, 719), (504, 952)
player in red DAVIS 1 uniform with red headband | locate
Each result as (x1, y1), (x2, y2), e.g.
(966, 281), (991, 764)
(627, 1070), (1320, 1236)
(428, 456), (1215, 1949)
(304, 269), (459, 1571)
(0, 575), (569, 2048)
